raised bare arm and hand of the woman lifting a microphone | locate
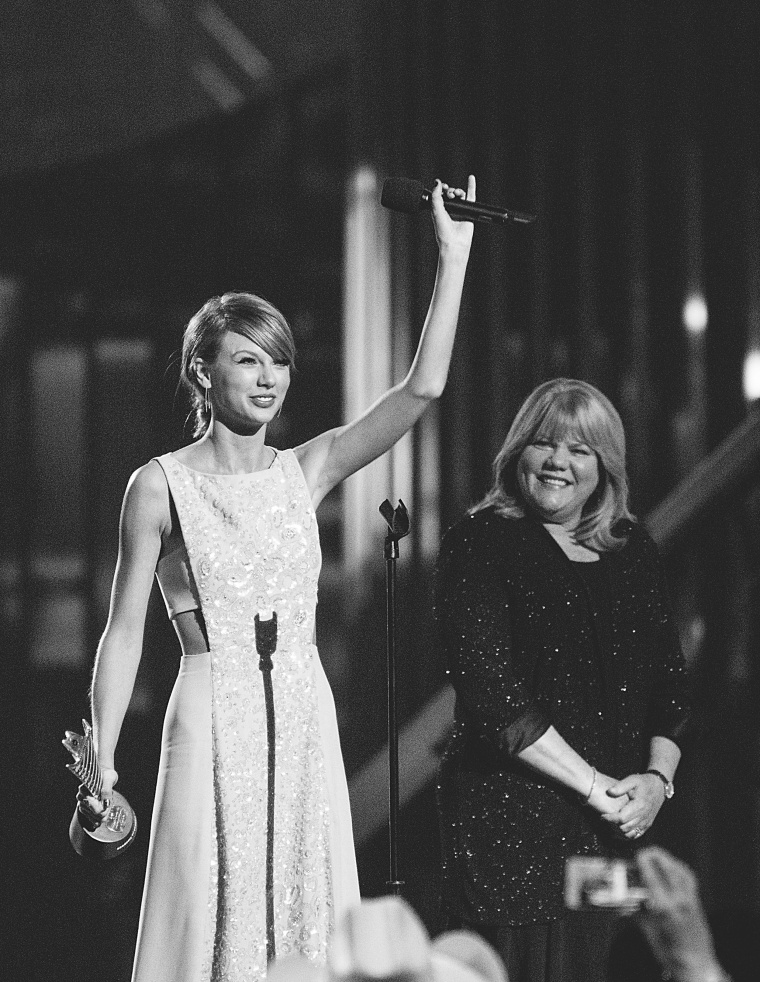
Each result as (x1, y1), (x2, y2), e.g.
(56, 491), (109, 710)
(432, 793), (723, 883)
(297, 175), (475, 506)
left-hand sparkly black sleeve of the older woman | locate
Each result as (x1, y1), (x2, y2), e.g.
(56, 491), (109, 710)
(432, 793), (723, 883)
(435, 515), (550, 755)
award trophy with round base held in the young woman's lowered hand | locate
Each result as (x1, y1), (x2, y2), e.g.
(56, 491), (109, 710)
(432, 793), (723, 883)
(61, 719), (137, 862)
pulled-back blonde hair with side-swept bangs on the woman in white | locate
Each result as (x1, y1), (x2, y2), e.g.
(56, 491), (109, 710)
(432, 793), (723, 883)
(180, 293), (296, 437)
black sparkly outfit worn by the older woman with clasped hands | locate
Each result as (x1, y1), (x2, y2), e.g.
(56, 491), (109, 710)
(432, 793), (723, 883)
(436, 509), (687, 926)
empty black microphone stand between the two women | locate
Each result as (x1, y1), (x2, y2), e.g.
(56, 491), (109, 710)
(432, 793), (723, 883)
(380, 498), (409, 896)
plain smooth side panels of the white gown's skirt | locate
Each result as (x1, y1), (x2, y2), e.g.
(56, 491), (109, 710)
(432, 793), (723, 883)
(132, 652), (359, 982)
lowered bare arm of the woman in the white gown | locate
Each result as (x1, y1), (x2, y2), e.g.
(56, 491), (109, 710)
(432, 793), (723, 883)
(87, 462), (169, 793)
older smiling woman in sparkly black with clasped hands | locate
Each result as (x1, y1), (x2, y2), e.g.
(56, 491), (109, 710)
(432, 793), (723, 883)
(436, 379), (686, 982)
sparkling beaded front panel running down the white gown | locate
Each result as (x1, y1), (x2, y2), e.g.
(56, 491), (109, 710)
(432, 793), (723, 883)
(160, 450), (333, 982)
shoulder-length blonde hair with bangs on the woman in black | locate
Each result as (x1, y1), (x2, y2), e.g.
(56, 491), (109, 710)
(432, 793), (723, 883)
(470, 378), (634, 551)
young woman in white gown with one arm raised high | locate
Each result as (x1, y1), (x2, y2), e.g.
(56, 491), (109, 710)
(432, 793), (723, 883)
(80, 177), (475, 982)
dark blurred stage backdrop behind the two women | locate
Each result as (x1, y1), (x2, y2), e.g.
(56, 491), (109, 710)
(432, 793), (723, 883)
(0, 0), (760, 982)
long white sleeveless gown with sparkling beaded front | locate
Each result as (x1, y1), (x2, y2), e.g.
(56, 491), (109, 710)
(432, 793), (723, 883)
(133, 450), (359, 982)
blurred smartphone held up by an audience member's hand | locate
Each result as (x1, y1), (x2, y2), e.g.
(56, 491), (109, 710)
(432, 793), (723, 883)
(565, 856), (647, 913)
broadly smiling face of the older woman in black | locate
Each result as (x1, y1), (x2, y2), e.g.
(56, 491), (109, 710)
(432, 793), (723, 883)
(517, 433), (599, 530)
